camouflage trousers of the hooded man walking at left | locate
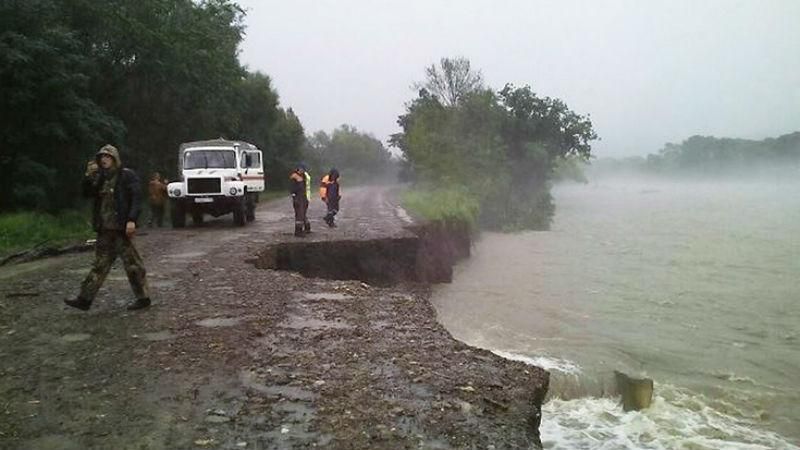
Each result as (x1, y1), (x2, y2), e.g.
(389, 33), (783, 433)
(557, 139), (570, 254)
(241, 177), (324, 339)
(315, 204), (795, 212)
(79, 230), (150, 302)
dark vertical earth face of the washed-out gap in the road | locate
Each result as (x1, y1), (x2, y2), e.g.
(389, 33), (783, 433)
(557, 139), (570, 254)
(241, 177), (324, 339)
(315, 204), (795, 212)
(254, 224), (471, 285)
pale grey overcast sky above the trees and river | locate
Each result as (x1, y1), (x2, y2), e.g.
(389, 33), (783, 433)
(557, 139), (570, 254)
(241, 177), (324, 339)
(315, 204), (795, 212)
(238, 0), (800, 157)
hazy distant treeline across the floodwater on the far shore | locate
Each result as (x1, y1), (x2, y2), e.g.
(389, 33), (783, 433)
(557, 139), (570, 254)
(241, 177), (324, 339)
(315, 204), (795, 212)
(592, 132), (800, 177)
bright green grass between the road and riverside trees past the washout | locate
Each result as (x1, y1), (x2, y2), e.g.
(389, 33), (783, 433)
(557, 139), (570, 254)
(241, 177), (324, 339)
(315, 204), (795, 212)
(400, 187), (480, 229)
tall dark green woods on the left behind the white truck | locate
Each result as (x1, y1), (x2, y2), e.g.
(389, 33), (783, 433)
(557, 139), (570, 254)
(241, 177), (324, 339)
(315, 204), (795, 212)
(0, 0), (305, 211)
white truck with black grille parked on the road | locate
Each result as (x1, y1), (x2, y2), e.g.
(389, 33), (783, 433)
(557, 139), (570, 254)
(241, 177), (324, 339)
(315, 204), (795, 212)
(167, 139), (264, 228)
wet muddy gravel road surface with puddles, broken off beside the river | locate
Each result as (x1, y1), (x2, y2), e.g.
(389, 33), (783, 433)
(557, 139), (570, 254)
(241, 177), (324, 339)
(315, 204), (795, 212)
(0, 185), (548, 450)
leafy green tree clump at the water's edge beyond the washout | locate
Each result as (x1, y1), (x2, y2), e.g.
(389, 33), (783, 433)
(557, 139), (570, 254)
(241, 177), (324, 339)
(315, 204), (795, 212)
(391, 58), (597, 230)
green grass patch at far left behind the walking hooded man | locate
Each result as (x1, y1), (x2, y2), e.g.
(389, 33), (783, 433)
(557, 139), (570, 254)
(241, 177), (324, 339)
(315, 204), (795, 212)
(0, 210), (94, 257)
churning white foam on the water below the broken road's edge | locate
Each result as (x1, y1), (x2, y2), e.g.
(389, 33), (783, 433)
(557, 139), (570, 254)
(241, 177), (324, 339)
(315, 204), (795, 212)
(540, 386), (800, 450)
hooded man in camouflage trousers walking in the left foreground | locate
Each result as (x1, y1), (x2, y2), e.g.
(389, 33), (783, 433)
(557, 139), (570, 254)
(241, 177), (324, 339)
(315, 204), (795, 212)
(64, 145), (150, 311)
